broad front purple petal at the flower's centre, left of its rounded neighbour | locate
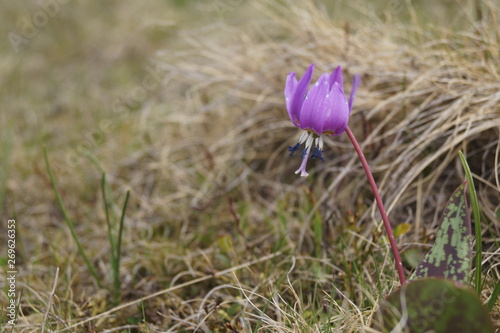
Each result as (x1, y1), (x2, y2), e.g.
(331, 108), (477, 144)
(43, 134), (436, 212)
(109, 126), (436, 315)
(299, 73), (331, 135)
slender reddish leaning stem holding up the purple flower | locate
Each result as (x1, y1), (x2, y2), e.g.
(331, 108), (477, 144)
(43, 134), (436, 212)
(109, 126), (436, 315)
(346, 127), (406, 285)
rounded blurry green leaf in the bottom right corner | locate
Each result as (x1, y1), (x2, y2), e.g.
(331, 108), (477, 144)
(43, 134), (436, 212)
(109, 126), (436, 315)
(372, 278), (493, 333)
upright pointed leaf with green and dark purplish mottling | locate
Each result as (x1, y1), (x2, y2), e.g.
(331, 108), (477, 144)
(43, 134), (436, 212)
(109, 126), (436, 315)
(410, 182), (472, 283)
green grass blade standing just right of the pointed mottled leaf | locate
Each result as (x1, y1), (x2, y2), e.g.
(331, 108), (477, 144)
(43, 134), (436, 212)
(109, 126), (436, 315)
(458, 150), (483, 295)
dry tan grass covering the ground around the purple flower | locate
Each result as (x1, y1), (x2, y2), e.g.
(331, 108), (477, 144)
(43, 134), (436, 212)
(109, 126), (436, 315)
(0, 0), (500, 332)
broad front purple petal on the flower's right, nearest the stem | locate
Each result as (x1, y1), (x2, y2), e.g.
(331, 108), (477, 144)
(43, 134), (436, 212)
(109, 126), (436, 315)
(322, 83), (349, 135)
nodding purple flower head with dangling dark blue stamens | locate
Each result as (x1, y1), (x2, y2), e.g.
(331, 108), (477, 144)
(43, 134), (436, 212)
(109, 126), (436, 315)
(285, 64), (360, 177)
